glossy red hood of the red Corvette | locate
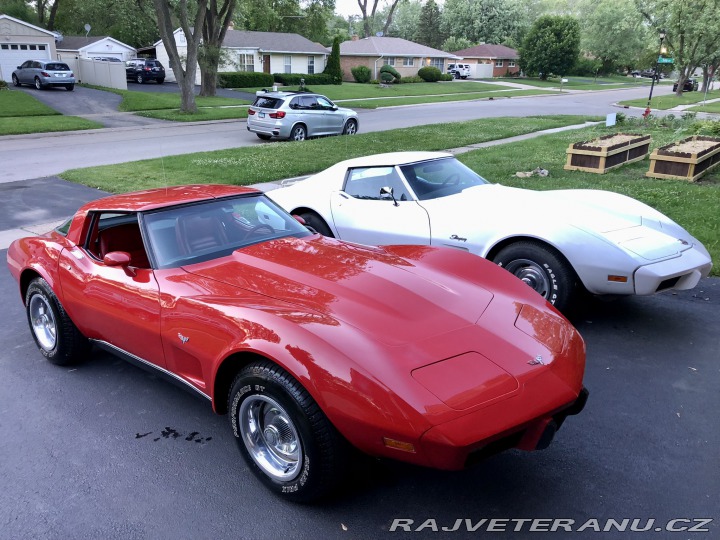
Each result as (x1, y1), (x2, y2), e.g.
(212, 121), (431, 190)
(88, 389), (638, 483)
(183, 235), (493, 345)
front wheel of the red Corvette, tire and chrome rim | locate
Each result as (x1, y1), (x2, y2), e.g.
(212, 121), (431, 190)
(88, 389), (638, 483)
(228, 361), (347, 502)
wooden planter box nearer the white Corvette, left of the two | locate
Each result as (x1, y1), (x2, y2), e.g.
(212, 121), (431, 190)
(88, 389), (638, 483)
(565, 133), (650, 174)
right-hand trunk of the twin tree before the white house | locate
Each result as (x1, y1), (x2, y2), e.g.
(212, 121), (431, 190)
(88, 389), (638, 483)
(198, 0), (236, 96)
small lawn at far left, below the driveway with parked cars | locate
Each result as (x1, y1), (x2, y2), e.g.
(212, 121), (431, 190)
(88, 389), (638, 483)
(0, 89), (102, 135)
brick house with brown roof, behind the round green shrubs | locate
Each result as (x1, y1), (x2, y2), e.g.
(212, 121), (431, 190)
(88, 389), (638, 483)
(340, 36), (459, 81)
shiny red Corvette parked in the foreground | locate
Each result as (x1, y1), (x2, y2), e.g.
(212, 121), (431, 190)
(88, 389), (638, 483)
(8, 185), (587, 501)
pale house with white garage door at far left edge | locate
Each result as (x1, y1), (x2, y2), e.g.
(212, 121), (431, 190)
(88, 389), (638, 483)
(0, 14), (58, 82)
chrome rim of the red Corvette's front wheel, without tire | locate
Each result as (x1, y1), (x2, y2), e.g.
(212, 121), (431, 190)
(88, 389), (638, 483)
(238, 395), (303, 482)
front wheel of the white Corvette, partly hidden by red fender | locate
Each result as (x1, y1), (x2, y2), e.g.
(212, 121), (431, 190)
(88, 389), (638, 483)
(493, 242), (576, 312)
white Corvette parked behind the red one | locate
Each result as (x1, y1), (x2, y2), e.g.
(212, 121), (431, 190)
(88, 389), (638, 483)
(269, 152), (712, 310)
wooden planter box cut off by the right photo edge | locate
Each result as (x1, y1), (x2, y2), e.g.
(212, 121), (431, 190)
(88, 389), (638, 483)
(645, 135), (720, 182)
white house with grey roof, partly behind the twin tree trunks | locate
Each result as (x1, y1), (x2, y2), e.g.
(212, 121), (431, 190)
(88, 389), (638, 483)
(155, 28), (330, 84)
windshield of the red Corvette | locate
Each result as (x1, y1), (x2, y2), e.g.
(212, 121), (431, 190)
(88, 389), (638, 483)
(142, 194), (310, 268)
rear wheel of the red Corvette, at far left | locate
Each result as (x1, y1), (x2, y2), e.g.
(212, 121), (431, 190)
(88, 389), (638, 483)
(25, 278), (90, 366)
